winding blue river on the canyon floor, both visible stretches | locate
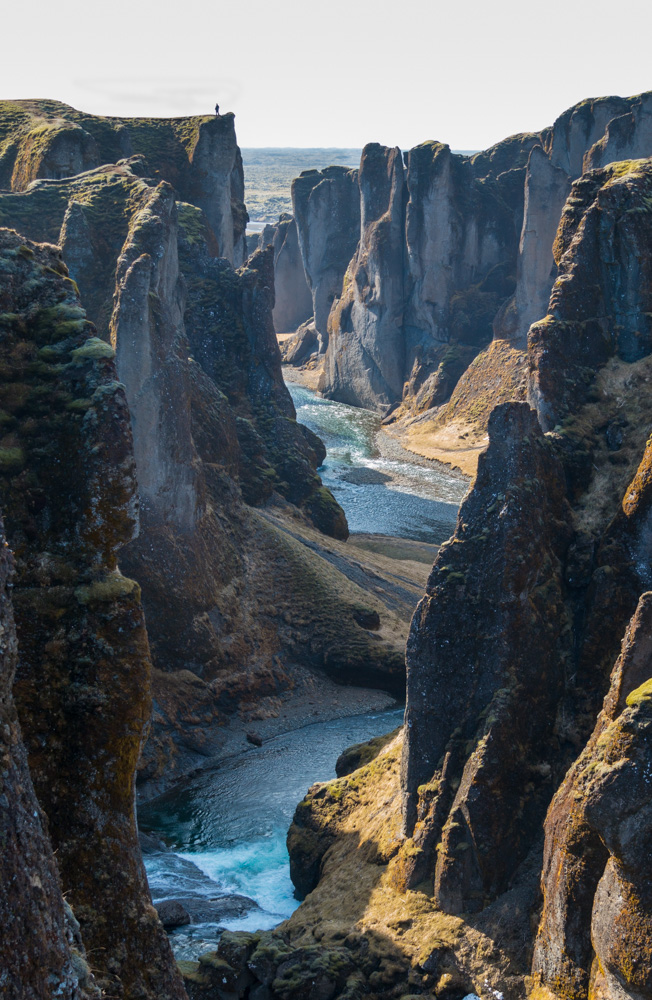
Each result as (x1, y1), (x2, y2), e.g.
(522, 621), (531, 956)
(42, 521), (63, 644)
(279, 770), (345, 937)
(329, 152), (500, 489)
(139, 384), (467, 959)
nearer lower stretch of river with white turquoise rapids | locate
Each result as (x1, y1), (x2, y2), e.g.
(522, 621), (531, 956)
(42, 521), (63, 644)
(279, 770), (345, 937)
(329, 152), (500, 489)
(139, 708), (403, 958)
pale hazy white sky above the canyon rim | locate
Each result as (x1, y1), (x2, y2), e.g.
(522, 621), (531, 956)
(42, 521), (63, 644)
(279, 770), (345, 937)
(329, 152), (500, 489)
(0, 0), (652, 150)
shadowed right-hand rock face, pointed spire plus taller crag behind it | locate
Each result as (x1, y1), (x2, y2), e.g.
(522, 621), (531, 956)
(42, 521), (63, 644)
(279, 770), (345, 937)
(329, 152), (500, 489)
(402, 154), (652, 928)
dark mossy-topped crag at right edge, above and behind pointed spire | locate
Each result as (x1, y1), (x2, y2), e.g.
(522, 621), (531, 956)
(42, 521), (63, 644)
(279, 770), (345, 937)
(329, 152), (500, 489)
(528, 160), (652, 430)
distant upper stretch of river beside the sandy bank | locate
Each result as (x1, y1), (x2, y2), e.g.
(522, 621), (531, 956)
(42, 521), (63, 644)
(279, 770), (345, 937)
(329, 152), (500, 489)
(287, 382), (468, 543)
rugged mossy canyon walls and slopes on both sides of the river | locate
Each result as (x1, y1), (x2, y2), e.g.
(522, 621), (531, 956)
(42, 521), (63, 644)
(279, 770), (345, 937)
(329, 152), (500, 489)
(0, 94), (652, 1000)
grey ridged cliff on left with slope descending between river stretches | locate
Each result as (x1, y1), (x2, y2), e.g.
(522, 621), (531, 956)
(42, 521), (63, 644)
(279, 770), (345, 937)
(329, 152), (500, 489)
(0, 135), (413, 790)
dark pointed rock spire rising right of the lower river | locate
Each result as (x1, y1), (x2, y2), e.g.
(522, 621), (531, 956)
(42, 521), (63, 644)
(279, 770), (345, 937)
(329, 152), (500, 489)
(403, 403), (572, 914)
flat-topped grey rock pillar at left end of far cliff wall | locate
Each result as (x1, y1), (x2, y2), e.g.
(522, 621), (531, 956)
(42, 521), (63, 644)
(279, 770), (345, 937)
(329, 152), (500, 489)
(292, 167), (361, 354)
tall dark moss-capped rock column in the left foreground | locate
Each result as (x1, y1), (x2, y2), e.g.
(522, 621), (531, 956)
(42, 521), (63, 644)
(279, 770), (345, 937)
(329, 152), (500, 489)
(0, 230), (184, 1000)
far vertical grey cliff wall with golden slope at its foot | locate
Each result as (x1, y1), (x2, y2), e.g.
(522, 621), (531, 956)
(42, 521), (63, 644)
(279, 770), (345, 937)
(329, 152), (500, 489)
(276, 94), (652, 450)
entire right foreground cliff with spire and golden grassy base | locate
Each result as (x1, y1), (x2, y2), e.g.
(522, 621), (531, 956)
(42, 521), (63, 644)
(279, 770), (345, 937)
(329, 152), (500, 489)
(232, 160), (652, 1000)
